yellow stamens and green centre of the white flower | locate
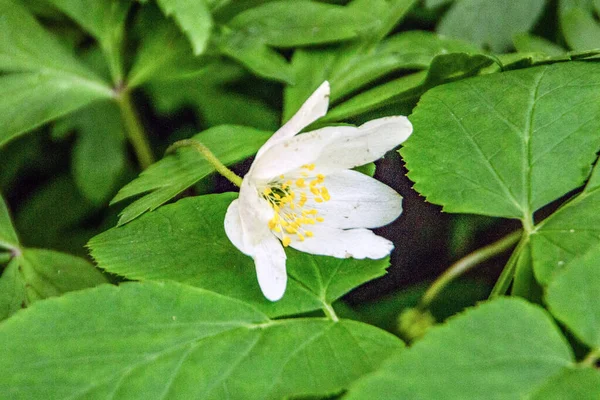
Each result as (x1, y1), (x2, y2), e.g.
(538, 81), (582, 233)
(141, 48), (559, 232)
(261, 164), (331, 247)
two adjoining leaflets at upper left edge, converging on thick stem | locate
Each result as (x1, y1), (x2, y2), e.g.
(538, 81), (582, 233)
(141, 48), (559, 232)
(0, 0), (113, 145)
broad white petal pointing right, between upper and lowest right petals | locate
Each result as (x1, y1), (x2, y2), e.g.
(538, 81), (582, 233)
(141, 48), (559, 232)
(307, 170), (402, 229)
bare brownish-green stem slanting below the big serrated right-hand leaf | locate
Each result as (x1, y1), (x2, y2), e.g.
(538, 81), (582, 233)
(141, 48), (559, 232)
(420, 230), (522, 309)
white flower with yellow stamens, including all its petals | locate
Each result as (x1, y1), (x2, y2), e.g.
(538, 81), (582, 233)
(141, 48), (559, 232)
(225, 82), (412, 301)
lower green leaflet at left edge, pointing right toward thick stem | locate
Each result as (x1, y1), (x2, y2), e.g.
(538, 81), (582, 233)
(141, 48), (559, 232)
(0, 72), (112, 145)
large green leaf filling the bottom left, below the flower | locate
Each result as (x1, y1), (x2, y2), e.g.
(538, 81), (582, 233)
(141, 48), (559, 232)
(0, 282), (403, 400)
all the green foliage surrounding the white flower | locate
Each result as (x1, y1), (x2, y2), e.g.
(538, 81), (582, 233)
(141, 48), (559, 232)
(0, 0), (600, 400)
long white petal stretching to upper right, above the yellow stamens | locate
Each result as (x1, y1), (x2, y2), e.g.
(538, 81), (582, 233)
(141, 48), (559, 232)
(252, 116), (412, 179)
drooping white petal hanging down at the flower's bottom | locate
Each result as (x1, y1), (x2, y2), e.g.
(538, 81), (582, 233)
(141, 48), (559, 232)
(253, 235), (287, 301)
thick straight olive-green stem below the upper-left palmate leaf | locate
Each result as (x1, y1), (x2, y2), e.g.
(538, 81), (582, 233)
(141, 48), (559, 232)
(116, 89), (154, 169)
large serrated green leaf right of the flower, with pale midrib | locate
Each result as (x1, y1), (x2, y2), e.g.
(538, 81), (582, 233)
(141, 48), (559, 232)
(401, 62), (600, 219)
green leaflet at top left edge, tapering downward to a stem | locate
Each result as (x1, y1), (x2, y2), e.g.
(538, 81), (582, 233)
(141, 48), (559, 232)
(48, 0), (131, 81)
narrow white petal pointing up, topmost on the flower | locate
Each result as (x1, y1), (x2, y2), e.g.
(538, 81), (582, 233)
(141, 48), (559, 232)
(256, 81), (329, 158)
